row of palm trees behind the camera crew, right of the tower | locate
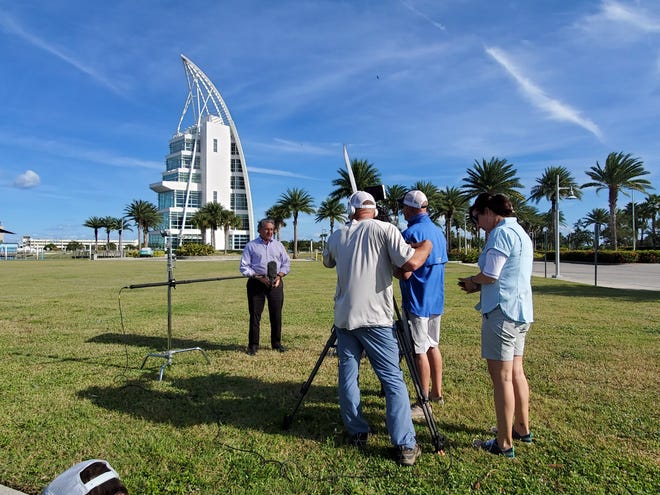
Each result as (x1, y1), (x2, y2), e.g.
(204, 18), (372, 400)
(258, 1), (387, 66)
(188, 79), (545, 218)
(266, 152), (660, 258)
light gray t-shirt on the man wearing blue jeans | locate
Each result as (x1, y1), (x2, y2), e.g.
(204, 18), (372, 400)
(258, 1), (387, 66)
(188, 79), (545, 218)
(323, 219), (415, 330)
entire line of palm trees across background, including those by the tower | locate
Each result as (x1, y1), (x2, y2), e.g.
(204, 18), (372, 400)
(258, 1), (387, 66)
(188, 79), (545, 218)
(84, 152), (660, 258)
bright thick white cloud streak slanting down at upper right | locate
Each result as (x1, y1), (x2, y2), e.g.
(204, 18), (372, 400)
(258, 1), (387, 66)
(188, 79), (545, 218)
(486, 47), (603, 141)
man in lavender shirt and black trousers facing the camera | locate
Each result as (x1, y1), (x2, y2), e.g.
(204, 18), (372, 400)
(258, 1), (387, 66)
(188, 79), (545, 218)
(240, 218), (290, 356)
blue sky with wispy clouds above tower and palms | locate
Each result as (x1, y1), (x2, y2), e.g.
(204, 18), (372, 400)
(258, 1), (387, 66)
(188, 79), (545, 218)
(0, 0), (660, 241)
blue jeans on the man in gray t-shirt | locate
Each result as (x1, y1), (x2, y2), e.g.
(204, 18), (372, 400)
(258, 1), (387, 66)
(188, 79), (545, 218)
(336, 327), (416, 448)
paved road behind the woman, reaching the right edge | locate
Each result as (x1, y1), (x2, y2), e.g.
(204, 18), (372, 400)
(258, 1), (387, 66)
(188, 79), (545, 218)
(533, 261), (660, 290)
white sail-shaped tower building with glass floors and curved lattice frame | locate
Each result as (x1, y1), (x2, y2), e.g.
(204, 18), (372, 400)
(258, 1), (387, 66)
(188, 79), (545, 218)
(149, 55), (254, 249)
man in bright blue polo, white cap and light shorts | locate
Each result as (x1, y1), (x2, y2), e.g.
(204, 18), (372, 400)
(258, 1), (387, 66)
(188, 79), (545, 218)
(396, 190), (448, 419)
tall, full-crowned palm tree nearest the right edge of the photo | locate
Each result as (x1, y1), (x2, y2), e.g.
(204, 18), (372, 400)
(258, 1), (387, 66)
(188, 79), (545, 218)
(582, 152), (653, 251)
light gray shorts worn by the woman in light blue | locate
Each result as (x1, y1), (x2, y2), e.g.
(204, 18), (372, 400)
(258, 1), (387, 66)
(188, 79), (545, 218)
(481, 306), (530, 361)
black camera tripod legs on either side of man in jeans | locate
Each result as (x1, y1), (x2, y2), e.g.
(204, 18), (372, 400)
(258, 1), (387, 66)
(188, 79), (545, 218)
(283, 299), (447, 452)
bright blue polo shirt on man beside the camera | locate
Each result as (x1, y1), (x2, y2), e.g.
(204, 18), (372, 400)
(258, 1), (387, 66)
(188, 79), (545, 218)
(399, 213), (448, 318)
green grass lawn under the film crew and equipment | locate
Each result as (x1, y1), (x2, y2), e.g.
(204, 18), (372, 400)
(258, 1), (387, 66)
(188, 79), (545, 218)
(0, 259), (660, 495)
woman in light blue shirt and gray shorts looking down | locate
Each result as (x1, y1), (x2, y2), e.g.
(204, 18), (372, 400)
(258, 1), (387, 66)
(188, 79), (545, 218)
(459, 193), (534, 457)
